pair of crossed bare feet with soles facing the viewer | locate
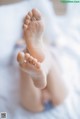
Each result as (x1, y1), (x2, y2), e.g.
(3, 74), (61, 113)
(17, 9), (46, 89)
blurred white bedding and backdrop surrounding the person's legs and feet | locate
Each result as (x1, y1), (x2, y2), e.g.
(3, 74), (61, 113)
(0, 0), (80, 119)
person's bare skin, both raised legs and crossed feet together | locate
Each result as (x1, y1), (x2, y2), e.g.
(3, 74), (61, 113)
(17, 9), (68, 112)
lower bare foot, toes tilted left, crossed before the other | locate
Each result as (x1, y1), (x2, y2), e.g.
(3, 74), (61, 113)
(17, 52), (47, 89)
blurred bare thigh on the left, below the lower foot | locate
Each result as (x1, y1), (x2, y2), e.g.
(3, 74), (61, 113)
(20, 70), (44, 112)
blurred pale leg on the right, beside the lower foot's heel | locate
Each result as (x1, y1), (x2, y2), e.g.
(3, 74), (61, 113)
(47, 59), (68, 106)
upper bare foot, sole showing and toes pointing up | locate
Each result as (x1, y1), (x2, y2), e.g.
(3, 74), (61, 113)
(23, 9), (45, 62)
